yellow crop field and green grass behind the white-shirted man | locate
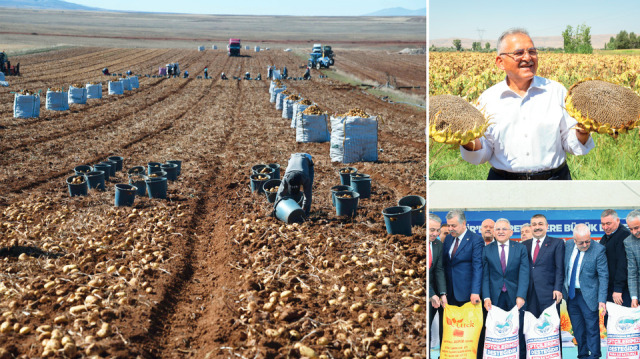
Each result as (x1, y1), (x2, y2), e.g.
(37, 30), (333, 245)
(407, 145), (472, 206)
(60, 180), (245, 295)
(429, 52), (640, 180)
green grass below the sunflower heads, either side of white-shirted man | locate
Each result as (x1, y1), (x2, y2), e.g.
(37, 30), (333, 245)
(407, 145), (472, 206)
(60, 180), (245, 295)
(429, 129), (640, 180)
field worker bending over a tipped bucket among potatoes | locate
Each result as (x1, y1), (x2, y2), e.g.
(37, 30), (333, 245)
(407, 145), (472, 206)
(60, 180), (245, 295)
(275, 153), (314, 217)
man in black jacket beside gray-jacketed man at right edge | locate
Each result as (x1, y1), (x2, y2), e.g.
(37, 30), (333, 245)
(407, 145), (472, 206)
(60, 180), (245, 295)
(600, 209), (631, 308)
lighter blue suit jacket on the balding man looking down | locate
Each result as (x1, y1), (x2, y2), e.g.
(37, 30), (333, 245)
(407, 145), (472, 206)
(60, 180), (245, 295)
(564, 240), (609, 311)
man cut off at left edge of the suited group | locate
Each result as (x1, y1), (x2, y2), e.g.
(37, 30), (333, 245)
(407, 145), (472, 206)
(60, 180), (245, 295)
(427, 213), (447, 352)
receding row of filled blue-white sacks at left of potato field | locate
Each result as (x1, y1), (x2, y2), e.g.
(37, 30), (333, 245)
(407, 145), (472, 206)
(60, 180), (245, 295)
(13, 76), (140, 118)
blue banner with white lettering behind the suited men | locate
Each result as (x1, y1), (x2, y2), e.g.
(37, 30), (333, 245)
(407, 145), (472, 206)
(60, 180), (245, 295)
(433, 209), (631, 239)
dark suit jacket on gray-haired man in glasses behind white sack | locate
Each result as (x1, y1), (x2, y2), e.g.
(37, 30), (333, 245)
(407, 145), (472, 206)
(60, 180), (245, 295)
(482, 241), (529, 306)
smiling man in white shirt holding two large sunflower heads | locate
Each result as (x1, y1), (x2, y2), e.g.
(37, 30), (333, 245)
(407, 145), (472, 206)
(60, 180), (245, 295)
(460, 29), (595, 180)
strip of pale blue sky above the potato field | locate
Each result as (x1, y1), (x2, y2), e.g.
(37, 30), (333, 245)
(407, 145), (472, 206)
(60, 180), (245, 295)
(67, 0), (426, 16)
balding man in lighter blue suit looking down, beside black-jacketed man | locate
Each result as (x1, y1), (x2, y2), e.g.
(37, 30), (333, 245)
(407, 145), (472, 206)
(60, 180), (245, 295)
(564, 223), (609, 358)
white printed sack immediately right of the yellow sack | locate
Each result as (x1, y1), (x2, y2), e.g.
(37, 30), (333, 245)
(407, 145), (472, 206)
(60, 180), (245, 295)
(483, 305), (520, 359)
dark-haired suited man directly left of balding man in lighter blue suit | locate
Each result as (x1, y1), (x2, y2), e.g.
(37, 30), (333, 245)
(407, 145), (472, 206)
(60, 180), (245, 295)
(520, 214), (564, 358)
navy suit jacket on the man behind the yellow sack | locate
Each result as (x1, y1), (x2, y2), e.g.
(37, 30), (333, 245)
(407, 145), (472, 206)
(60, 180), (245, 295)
(442, 229), (484, 302)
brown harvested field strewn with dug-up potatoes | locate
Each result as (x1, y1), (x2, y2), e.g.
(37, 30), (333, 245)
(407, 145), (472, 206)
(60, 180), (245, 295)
(0, 47), (427, 358)
